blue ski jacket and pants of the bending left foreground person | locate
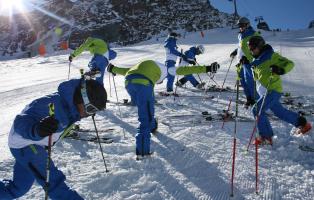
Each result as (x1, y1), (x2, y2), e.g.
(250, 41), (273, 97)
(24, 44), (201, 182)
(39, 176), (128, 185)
(0, 79), (83, 200)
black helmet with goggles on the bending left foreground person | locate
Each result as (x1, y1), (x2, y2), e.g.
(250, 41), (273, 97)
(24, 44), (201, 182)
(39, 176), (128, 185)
(73, 79), (107, 110)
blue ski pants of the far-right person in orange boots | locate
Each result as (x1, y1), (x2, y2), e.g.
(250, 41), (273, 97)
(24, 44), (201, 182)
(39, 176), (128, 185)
(252, 91), (299, 137)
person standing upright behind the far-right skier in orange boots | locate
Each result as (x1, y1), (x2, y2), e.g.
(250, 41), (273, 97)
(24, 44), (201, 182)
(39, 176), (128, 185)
(230, 17), (259, 108)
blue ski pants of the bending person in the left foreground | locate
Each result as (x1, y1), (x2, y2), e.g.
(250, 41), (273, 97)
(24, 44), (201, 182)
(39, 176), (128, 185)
(0, 145), (83, 200)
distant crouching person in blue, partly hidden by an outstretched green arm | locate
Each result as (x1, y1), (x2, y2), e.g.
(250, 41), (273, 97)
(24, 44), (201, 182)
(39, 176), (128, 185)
(176, 45), (205, 89)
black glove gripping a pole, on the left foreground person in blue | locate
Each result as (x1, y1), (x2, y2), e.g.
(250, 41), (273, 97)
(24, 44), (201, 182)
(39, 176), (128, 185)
(36, 116), (59, 137)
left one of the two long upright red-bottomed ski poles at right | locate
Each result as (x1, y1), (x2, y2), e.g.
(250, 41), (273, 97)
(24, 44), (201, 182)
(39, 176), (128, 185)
(230, 79), (239, 197)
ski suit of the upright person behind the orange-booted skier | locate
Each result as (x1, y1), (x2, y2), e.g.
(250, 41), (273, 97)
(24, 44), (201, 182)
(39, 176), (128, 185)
(237, 26), (259, 99)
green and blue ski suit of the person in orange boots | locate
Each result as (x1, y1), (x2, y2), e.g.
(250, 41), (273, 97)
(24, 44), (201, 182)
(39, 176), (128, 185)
(251, 44), (299, 137)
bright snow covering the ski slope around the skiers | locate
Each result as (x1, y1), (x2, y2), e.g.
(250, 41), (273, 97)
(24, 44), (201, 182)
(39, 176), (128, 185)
(0, 28), (314, 200)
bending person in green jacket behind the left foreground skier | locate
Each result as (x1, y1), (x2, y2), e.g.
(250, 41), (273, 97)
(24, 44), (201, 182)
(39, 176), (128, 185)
(69, 36), (117, 85)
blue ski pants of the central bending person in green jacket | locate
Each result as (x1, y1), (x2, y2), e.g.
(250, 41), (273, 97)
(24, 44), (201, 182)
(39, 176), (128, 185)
(126, 75), (157, 155)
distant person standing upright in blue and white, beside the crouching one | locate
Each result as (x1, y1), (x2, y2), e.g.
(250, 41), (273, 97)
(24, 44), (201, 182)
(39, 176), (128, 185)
(164, 32), (186, 94)
